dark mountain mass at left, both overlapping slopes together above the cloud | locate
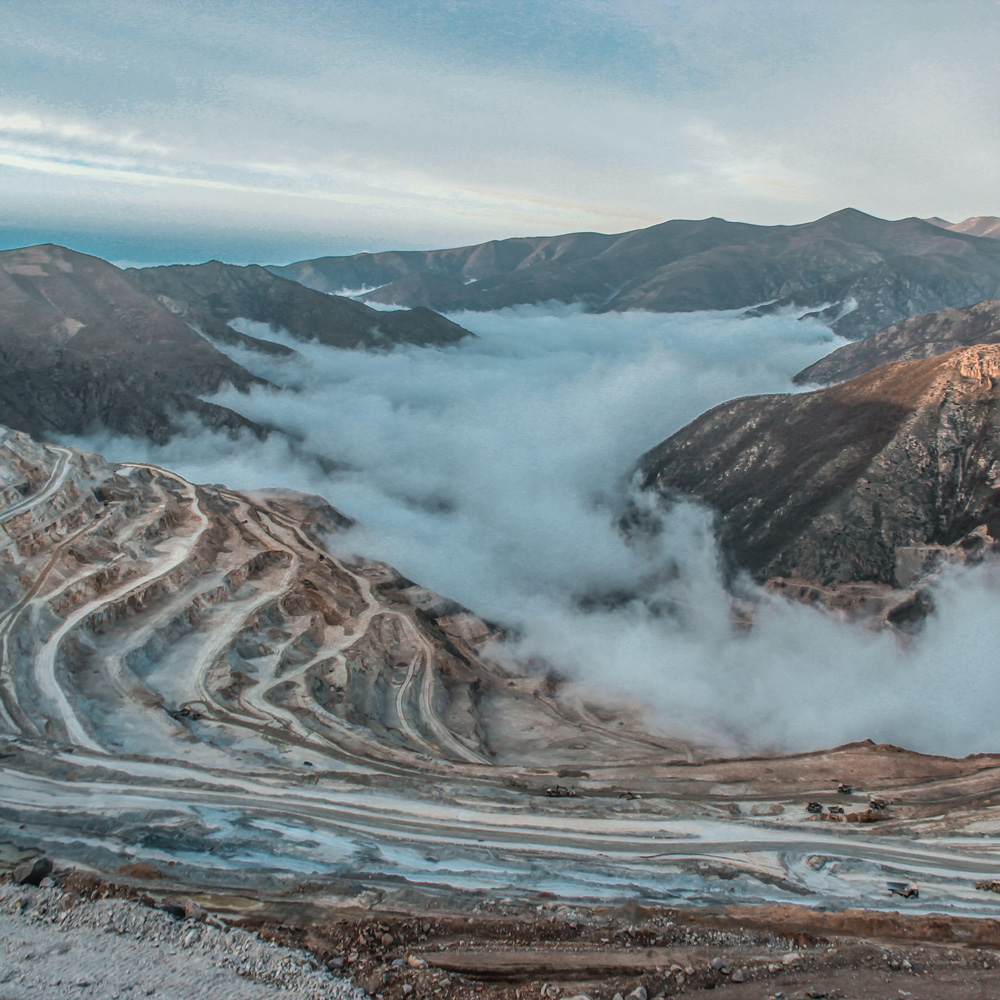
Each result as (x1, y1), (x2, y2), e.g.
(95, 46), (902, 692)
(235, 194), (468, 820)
(0, 244), (470, 443)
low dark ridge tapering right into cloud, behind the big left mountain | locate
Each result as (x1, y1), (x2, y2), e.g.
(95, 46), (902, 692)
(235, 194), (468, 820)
(125, 260), (471, 349)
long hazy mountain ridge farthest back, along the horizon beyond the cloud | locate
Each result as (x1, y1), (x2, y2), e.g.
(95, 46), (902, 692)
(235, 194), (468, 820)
(268, 209), (1000, 339)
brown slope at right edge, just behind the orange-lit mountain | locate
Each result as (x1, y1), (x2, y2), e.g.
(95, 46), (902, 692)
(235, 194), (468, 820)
(793, 299), (1000, 385)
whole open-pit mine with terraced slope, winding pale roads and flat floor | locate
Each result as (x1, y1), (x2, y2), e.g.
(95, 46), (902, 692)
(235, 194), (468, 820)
(0, 431), (1000, 996)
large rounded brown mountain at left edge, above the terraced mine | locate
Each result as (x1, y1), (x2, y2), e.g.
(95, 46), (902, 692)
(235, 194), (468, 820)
(0, 245), (266, 442)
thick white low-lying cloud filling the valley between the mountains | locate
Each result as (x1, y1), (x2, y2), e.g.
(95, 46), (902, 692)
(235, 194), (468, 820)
(73, 307), (1000, 754)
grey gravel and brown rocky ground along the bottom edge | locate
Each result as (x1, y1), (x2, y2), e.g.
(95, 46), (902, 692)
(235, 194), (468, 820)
(0, 869), (1000, 1000)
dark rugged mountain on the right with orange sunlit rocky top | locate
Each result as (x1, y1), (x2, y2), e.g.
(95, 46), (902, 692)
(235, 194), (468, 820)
(639, 345), (1000, 586)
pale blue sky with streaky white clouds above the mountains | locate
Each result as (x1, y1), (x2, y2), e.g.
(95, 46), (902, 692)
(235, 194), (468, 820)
(0, 0), (1000, 264)
